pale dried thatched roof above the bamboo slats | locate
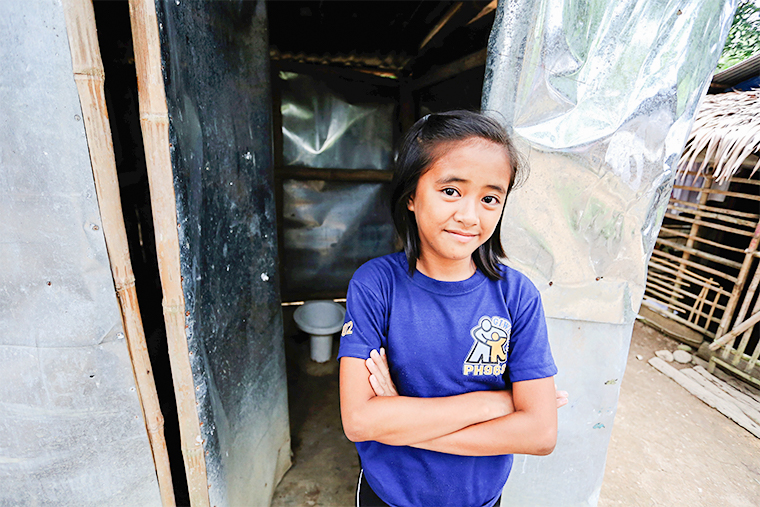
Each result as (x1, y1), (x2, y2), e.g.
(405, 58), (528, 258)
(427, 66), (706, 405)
(678, 90), (760, 183)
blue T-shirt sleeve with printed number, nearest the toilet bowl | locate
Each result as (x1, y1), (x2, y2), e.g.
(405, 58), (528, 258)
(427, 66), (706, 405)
(338, 279), (387, 359)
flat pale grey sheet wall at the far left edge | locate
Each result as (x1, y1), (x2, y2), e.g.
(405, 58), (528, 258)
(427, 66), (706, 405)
(0, 0), (161, 507)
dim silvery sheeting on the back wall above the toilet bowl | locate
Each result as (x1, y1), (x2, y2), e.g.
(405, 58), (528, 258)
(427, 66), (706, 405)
(279, 72), (398, 299)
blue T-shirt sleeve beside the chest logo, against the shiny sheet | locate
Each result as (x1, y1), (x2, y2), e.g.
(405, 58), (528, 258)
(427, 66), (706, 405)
(508, 282), (557, 382)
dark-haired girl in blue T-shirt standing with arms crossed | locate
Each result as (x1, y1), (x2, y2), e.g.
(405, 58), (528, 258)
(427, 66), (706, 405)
(338, 111), (564, 507)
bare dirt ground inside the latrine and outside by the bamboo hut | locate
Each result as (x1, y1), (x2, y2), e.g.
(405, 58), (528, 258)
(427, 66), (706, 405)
(272, 318), (760, 507)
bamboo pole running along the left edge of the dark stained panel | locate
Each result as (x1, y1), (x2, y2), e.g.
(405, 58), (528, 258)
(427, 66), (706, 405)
(129, 0), (209, 507)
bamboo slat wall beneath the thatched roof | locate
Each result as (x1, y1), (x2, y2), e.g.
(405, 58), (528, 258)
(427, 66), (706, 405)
(643, 167), (760, 386)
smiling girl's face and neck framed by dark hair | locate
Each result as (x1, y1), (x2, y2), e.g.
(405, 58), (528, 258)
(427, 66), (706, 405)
(407, 138), (512, 280)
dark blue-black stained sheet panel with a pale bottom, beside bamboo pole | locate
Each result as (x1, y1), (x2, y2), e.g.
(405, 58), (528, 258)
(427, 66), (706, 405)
(157, 0), (290, 507)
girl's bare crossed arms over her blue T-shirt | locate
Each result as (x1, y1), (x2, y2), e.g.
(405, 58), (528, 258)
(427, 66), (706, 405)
(340, 351), (567, 456)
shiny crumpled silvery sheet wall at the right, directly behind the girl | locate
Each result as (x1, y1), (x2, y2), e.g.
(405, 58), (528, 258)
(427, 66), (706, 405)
(483, 0), (735, 507)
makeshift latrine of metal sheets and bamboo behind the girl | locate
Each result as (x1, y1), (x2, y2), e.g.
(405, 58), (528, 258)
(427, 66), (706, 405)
(0, 0), (744, 506)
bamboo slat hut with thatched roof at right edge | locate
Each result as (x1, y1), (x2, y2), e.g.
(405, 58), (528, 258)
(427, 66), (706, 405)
(642, 91), (760, 385)
